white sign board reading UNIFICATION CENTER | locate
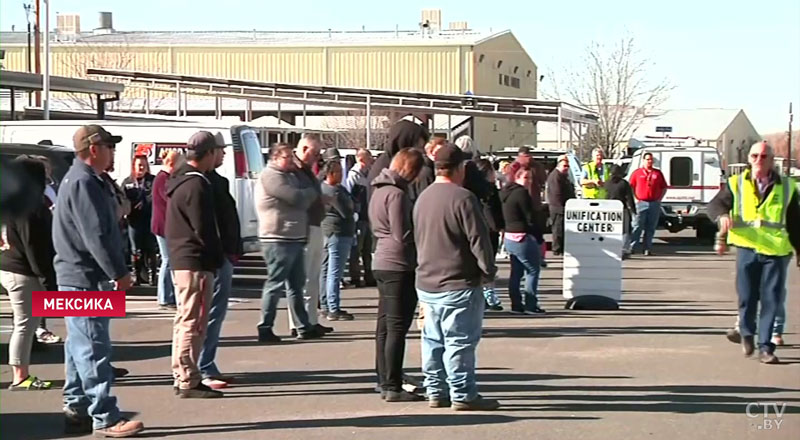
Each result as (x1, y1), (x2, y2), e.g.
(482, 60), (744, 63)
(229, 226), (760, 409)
(564, 199), (624, 303)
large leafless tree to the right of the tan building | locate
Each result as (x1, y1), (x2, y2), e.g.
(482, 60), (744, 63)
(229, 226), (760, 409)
(545, 37), (674, 156)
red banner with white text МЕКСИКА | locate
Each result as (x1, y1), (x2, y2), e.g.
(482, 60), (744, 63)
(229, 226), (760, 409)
(33, 290), (125, 318)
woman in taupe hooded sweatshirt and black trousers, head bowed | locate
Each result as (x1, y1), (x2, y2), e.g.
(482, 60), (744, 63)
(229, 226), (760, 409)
(369, 148), (424, 402)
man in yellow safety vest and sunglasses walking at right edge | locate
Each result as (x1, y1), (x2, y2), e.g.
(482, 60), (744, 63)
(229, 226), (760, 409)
(708, 142), (800, 364)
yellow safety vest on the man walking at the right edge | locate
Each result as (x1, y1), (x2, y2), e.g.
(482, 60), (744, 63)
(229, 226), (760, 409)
(728, 170), (795, 257)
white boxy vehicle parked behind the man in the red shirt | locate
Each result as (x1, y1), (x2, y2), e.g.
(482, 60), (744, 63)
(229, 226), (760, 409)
(627, 146), (724, 241)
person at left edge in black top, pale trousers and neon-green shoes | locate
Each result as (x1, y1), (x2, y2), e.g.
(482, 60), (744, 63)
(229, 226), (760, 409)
(0, 156), (58, 391)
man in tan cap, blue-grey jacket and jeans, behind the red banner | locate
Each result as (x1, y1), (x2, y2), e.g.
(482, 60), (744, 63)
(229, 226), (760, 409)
(53, 125), (144, 438)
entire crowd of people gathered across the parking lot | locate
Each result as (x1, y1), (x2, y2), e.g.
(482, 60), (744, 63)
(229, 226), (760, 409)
(0, 120), (800, 437)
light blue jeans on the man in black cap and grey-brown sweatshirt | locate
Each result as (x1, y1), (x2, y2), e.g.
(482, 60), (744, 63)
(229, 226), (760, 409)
(417, 287), (484, 402)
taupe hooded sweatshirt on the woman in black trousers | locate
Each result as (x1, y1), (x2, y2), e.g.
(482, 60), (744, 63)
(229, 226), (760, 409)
(369, 169), (417, 272)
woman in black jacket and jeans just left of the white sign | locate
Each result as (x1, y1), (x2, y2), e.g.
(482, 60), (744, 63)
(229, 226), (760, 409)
(500, 163), (545, 314)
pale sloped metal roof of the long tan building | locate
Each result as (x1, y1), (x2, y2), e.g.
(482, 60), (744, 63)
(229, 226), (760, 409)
(0, 30), (510, 47)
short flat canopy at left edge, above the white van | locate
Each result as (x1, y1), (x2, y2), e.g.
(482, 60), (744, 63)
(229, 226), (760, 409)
(0, 70), (125, 119)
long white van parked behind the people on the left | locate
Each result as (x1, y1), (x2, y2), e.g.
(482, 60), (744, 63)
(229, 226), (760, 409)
(0, 120), (264, 252)
